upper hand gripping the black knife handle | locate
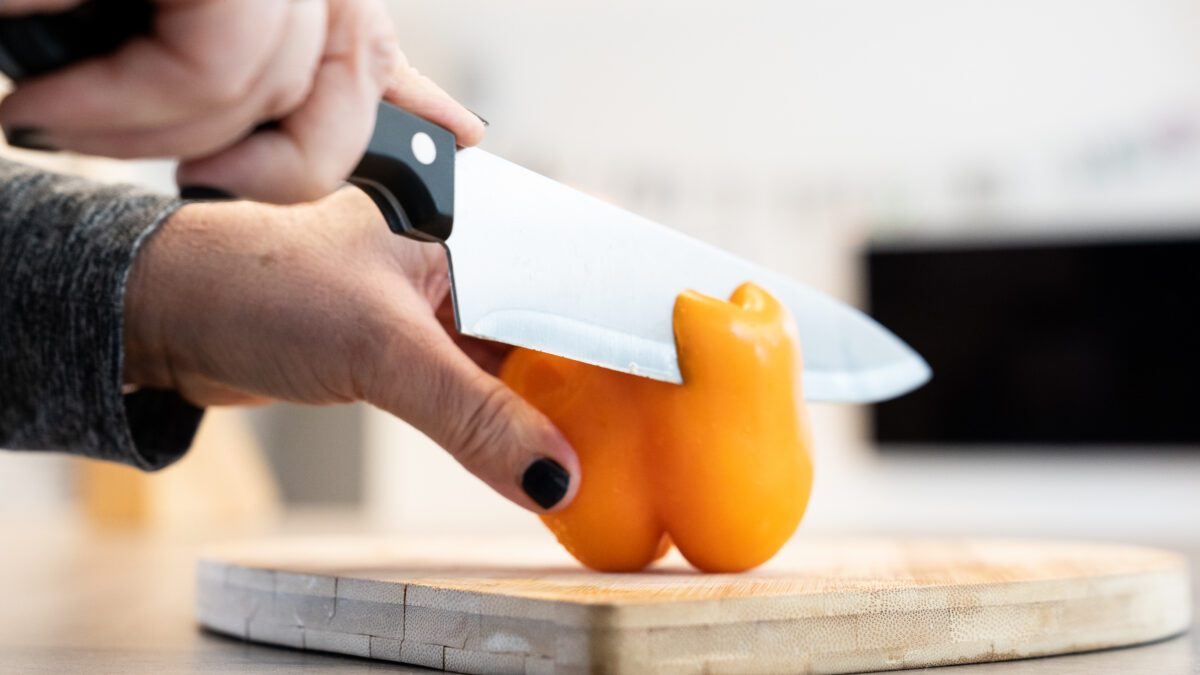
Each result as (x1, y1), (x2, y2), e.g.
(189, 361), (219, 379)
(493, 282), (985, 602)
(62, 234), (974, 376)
(0, 0), (484, 203)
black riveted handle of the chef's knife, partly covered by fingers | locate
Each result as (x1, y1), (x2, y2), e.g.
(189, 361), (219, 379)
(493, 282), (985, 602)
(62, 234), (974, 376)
(0, 0), (457, 241)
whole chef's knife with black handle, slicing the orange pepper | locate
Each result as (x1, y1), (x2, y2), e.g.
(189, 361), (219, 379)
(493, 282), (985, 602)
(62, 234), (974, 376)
(0, 0), (930, 402)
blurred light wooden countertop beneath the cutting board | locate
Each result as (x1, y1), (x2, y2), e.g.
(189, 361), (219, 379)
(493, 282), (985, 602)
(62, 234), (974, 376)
(0, 518), (1200, 675)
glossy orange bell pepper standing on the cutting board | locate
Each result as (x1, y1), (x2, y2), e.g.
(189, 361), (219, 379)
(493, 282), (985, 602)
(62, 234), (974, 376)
(500, 283), (812, 572)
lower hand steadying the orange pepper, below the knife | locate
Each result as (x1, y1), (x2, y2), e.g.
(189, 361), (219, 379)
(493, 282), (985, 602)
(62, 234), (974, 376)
(125, 187), (580, 513)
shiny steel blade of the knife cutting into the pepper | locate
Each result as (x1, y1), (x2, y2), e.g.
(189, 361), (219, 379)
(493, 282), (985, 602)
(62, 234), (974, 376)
(448, 149), (930, 402)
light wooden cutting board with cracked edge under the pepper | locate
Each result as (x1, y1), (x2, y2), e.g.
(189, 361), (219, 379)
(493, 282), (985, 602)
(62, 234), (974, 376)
(197, 538), (1192, 673)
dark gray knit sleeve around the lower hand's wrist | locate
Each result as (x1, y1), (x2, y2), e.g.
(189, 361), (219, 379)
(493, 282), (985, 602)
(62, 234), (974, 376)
(0, 160), (203, 470)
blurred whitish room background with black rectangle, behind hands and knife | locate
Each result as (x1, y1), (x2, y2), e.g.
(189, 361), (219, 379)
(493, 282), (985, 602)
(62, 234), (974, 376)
(0, 0), (1200, 542)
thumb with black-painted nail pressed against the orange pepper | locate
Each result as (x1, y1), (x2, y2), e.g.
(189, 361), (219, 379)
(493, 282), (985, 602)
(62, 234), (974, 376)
(368, 327), (580, 513)
